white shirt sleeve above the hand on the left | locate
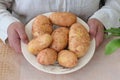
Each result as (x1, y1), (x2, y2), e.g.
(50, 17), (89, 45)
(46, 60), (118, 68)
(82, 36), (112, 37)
(0, 0), (19, 42)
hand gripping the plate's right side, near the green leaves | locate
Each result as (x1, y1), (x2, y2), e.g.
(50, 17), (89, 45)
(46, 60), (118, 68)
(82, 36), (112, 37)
(88, 18), (104, 48)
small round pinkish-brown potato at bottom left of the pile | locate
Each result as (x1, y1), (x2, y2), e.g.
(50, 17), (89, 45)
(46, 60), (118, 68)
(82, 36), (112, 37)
(37, 48), (57, 65)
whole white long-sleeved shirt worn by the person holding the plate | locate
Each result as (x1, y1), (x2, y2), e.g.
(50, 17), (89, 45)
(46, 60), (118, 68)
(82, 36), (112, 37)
(0, 0), (120, 41)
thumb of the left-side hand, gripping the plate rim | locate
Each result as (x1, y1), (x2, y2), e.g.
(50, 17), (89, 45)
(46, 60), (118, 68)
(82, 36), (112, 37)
(17, 25), (28, 44)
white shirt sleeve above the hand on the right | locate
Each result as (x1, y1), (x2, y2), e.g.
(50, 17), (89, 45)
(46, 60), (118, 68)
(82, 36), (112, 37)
(90, 0), (120, 29)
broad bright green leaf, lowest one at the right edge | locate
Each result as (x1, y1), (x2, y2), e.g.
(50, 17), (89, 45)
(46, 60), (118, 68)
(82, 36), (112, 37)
(105, 39), (120, 55)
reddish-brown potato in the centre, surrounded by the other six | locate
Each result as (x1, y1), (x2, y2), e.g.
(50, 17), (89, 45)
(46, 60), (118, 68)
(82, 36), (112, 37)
(50, 27), (69, 52)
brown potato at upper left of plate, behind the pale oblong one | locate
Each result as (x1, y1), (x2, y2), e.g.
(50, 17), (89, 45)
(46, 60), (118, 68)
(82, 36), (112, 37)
(32, 15), (52, 37)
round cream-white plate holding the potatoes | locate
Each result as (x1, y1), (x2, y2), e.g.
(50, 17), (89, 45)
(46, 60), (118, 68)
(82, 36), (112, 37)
(21, 13), (95, 74)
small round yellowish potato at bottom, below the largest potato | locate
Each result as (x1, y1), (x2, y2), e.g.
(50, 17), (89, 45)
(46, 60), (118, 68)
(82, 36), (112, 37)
(58, 50), (78, 68)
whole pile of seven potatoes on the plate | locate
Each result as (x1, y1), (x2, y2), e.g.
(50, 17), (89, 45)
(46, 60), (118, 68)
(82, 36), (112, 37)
(28, 12), (90, 67)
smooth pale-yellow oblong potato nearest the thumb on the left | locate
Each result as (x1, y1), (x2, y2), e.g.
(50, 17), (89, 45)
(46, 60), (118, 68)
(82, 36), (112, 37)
(28, 34), (52, 55)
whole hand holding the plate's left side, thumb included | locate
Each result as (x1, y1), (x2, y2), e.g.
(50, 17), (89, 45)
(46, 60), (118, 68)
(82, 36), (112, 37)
(7, 22), (28, 53)
